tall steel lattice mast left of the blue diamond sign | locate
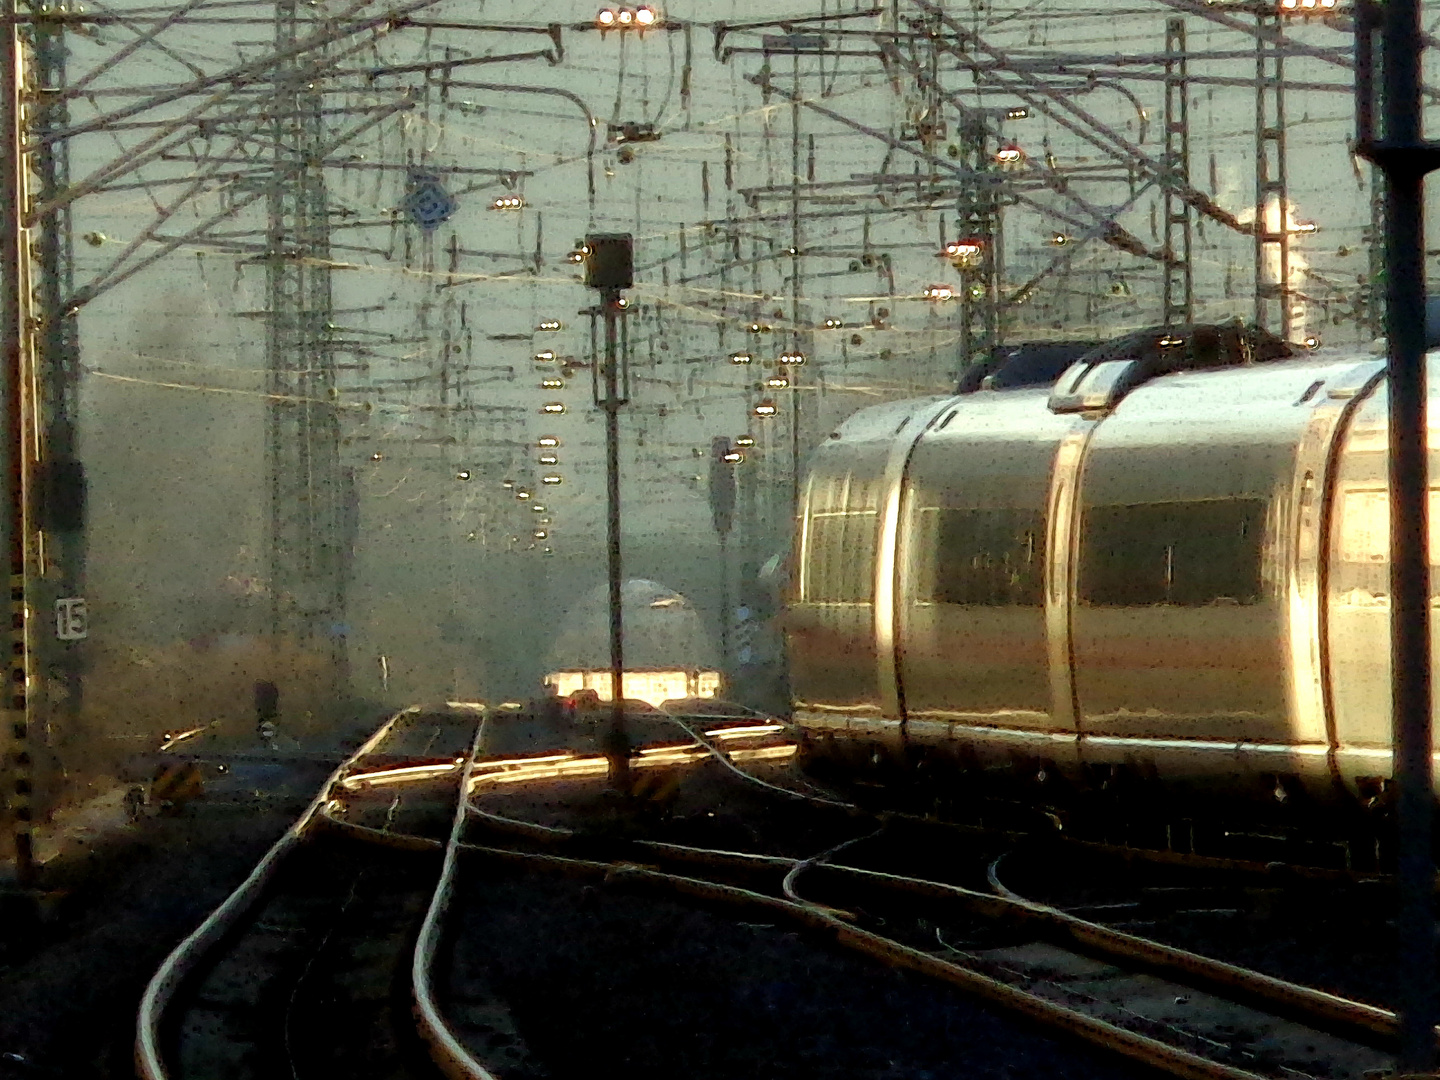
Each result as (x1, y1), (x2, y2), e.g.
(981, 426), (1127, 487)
(265, 0), (353, 696)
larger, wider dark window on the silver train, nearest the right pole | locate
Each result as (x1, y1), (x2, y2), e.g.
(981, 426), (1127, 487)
(1080, 498), (1266, 608)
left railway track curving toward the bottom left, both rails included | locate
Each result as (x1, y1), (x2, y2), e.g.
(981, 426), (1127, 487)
(135, 710), (504, 1080)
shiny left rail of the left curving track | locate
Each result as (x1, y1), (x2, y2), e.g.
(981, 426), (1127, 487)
(135, 706), (420, 1080)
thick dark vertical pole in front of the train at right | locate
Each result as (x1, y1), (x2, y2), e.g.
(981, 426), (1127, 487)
(1381, 0), (1436, 1073)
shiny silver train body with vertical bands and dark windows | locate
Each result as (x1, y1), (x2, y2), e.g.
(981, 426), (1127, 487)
(785, 342), (1440, 799)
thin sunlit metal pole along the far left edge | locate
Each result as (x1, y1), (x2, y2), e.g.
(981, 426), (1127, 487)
(0, 10), (36, 887)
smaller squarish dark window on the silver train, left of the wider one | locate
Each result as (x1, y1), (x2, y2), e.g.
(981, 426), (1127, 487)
(930, 507), (1045, 606)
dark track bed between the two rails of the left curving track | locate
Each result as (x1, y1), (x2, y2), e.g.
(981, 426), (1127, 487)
(166, 835), (439, 1080)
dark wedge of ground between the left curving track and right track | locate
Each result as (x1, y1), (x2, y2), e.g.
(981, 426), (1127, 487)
(446, 860), (1151, 1080)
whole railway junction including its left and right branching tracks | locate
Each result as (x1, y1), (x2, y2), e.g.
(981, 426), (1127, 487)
(137, 705), (1422, 1080)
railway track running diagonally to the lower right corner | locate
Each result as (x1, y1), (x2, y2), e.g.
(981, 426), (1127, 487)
(446, 714), (1395, 1080)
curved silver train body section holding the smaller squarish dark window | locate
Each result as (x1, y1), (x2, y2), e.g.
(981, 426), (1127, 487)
(896, 390), (1071, 762)
